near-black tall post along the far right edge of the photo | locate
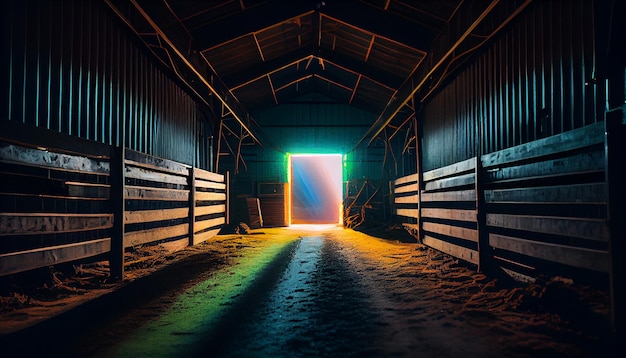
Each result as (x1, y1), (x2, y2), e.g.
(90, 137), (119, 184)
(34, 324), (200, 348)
(594, 1), (626, 344)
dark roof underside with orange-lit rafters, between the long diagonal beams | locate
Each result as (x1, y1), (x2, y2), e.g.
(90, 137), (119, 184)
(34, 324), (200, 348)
(162, 0), (460, 114)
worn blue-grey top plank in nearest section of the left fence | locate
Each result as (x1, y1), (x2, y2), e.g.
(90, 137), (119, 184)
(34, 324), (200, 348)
(0, 144), (110, 175)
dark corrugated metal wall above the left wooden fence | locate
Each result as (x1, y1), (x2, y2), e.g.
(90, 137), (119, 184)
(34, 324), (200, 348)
(0, 0), (206, 164)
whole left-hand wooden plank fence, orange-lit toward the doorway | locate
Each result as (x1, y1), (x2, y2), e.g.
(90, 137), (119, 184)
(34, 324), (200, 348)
(0, 121), (227, 278)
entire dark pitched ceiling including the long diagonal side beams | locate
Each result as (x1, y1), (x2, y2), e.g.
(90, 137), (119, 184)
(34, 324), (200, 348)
(105, 0), (516, 143)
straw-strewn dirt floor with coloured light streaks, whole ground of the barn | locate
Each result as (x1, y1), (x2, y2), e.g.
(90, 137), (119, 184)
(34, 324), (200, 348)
(0, 227), (618, 357)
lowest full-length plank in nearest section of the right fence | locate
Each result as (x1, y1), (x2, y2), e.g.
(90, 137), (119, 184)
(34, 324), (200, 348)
(489, 234), (610, 272)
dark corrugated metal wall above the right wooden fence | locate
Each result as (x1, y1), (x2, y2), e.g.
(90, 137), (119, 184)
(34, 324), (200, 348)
(422, 1), (604, 171)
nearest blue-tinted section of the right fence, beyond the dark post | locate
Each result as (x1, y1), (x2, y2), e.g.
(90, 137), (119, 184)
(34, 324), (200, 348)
(481, 122), (610, 273)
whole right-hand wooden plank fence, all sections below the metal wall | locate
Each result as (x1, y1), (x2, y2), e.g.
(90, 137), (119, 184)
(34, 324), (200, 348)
(394, 122), (611, 275)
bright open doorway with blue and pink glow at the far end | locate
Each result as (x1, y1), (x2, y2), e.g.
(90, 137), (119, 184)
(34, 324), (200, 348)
(288, 154), (343, 224)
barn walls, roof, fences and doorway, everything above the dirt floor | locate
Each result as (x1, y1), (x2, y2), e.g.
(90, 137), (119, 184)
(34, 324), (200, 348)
(0, 0), (626, 356)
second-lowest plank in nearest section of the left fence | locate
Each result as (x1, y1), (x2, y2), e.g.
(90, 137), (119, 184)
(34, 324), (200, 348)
(0, 213), (113, 236)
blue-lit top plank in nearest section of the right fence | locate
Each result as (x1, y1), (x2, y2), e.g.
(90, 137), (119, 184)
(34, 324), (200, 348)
(481, 122), (604, 168)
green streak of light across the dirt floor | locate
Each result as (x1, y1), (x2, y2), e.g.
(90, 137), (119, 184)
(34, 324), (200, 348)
(97, 237), (297, 358)
